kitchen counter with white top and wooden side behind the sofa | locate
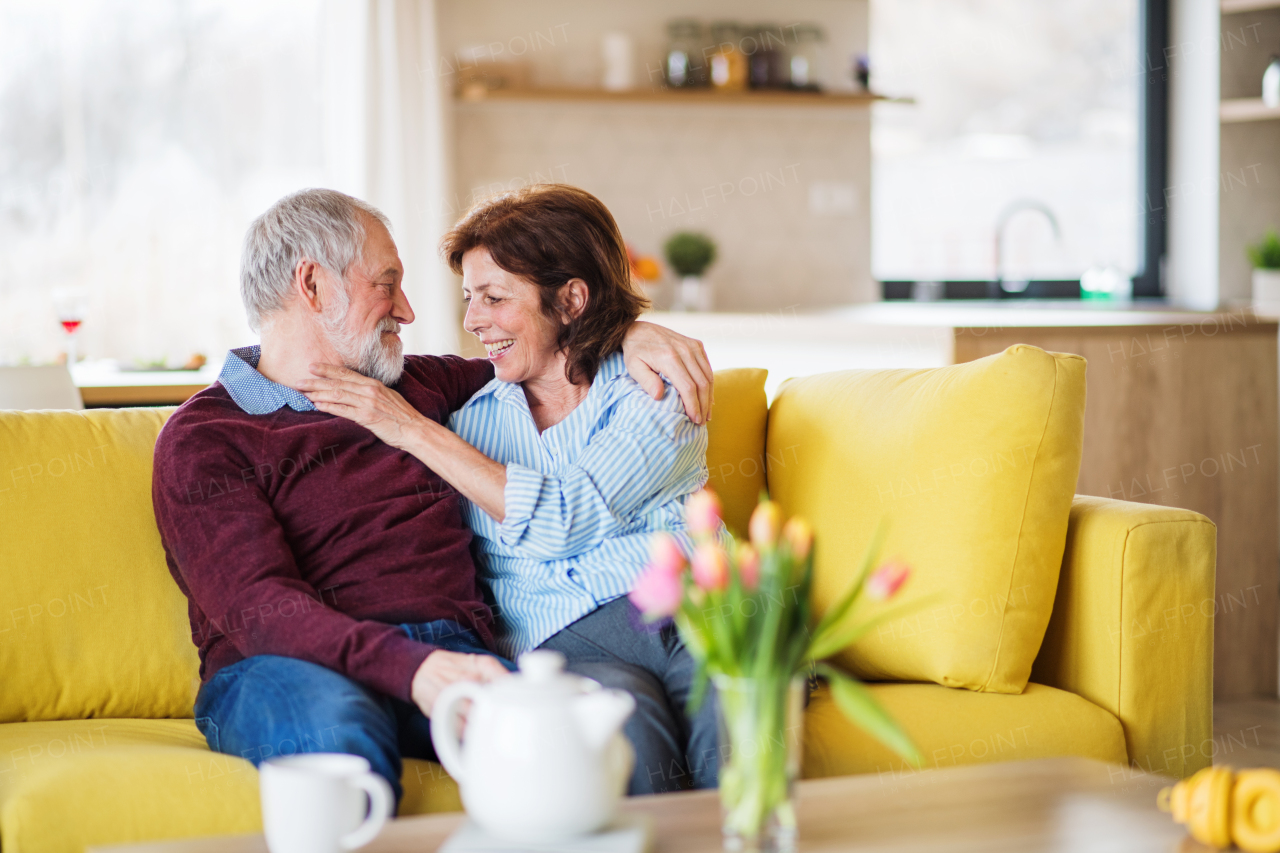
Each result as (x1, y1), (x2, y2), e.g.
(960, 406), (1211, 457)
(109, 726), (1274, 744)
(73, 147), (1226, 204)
(644, 300), (1280, 699)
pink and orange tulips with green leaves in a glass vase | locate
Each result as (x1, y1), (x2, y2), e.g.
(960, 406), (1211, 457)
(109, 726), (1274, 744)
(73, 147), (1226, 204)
(631, 489), (919, 847)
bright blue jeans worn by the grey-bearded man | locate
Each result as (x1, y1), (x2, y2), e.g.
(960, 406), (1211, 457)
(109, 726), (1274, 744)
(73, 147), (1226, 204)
(196, 620), (516, 804)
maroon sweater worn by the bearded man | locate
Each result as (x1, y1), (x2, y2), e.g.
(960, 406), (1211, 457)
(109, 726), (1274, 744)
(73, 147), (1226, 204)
(152, 356), (493, 699)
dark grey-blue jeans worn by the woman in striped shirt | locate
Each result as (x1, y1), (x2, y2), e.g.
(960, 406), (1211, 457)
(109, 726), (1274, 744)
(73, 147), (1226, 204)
(540, 598), (719, 794)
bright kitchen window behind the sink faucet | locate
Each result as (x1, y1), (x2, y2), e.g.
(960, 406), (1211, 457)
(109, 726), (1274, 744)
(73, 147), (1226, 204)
(870, 0), (1158, 296)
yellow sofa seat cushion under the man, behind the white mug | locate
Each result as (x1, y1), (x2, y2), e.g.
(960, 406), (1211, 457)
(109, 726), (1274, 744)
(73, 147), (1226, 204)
(0, 720), (462, 853)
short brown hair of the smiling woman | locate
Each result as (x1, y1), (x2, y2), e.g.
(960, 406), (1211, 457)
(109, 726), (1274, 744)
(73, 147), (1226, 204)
(440, 183), (649, 384)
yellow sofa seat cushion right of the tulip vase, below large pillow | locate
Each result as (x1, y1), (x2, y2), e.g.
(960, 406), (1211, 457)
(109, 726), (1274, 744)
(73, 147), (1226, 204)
(804, 684), (1129, 783)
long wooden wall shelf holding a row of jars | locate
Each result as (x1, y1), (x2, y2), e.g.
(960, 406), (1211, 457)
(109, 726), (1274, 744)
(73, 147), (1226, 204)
(457, 88), (914, 109)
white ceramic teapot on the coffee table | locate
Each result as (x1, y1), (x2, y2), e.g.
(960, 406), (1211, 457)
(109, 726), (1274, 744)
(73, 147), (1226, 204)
(431, 651), (635, 844)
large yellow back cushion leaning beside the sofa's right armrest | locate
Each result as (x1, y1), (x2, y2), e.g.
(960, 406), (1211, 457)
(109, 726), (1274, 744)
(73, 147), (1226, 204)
(768, 345), (1084, 693)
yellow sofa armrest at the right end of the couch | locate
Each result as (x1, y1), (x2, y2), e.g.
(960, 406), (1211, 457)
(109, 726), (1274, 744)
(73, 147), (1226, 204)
(1032, 494), (1217, 777)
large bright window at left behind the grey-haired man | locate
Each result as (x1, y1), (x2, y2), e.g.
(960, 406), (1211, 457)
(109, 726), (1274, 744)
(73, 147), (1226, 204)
(0, 0), (324, 364)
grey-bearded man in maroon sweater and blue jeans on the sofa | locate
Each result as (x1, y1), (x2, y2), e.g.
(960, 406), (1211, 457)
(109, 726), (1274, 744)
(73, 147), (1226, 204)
(152, 190), (710, 802)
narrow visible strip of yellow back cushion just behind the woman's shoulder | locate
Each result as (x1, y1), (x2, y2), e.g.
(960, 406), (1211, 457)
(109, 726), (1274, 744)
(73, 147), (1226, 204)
(707, 368), (769, 534)
